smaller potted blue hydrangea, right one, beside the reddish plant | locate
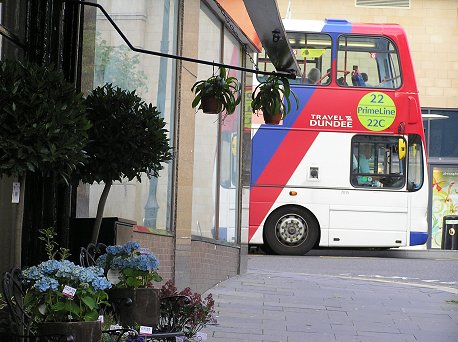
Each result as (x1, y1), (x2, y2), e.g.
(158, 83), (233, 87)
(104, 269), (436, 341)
(96, 241), (162, 326)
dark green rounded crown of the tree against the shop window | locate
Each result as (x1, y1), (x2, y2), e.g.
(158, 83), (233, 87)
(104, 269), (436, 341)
(77, 84), (172, 183)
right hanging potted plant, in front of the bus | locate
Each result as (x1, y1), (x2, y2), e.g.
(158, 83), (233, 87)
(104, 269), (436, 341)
(251, 74), (299, 124)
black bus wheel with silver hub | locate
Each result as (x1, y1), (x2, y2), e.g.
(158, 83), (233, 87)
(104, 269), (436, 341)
(264, 206), (319, 255)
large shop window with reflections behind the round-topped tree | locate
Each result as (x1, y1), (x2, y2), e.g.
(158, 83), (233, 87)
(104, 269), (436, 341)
(77, 0), (178, 229)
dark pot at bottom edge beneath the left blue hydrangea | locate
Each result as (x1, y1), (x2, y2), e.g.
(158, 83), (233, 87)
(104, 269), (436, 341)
(38, 321), (102, 342)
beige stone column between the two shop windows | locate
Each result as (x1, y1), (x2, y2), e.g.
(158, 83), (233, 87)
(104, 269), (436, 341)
(175, 0), (200, 289)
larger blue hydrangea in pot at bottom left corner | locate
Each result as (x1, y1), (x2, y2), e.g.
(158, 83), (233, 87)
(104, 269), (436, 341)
(21, 229), (111, 341)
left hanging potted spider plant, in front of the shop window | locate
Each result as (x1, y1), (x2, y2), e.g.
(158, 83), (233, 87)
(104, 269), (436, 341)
(191, 67), (241, 115)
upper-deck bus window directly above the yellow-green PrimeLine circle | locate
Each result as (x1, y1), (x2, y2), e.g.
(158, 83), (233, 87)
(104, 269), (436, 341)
(337, 36), (402, 89)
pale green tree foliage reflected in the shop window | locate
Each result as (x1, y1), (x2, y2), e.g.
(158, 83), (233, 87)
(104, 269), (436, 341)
(94, 33), (148, 93)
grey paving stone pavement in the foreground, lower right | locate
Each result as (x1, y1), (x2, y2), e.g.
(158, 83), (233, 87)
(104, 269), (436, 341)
(202, 270), (458, 342)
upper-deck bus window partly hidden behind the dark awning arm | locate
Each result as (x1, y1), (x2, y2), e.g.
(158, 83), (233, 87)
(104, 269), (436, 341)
(258, 32), (331, 86)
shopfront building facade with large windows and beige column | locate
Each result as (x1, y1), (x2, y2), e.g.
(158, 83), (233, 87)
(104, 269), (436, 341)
(0, 0), (256, 292)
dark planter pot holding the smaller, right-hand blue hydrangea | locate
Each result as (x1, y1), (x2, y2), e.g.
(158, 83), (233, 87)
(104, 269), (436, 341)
(108, 288), (160, 326)
